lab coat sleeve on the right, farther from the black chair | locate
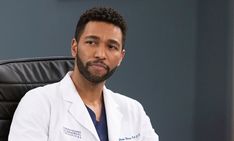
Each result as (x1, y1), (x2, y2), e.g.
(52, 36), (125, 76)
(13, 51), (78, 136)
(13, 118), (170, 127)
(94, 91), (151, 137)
(138, 103), (159, 141)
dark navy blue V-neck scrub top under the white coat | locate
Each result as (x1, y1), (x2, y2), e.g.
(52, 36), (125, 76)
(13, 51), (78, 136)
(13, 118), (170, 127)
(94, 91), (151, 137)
(86, 105), (108, 141)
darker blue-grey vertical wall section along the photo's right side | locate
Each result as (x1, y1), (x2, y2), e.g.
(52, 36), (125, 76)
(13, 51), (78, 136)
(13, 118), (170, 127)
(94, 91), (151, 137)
(194, 0), (234, 141)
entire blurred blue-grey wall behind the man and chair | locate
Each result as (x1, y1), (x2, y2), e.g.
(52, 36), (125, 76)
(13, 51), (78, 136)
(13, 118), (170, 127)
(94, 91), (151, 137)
(0, 0), (233, 141)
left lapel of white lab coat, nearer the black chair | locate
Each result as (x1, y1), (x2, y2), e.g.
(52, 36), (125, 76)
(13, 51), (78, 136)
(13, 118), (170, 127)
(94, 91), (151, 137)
(61, 75), (99, 141)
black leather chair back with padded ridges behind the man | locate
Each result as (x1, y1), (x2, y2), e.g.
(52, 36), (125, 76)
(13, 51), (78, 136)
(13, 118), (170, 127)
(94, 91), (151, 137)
(0, 57), (74, 141)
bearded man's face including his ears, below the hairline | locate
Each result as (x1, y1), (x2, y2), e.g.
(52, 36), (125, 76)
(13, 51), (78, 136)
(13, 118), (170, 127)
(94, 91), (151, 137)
(72, 22), (125, 84)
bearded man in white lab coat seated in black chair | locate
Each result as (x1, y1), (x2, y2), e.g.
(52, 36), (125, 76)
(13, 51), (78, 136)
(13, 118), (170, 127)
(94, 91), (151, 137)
(9, 7), (158, 141)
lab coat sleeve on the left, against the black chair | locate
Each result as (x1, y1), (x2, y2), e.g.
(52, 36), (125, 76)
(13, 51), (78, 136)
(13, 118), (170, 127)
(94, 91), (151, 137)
(8, 90), (49, 141)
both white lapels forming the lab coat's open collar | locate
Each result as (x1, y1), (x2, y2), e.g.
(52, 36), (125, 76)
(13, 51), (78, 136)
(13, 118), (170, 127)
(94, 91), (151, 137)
(61, 72), (123, 141)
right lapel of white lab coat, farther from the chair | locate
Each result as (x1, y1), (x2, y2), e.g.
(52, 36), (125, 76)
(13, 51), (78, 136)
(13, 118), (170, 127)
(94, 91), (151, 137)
(103, 87), (123, 141)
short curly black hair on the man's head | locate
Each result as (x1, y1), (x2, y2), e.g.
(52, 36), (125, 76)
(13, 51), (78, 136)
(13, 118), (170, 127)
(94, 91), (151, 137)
(74, 7), (127, 49)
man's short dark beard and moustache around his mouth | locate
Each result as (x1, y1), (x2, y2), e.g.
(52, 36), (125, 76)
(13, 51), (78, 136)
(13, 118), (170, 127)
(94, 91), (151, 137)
(76, 52), (117, 84)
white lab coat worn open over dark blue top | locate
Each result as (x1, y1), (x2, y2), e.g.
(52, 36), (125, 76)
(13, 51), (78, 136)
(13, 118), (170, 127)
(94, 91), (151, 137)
(9, 73), (158, 141)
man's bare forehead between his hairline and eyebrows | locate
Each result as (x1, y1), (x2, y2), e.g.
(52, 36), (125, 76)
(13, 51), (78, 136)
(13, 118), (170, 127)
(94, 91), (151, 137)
(81, 21), (122, 43)
